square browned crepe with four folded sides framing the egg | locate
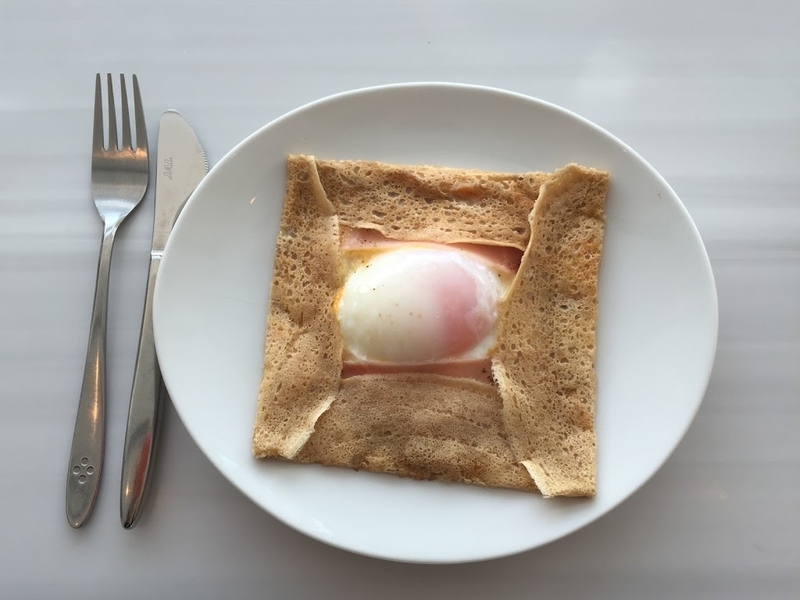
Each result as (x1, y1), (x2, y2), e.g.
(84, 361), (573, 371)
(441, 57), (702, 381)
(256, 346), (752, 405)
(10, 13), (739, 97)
(252, 155), (608, 496)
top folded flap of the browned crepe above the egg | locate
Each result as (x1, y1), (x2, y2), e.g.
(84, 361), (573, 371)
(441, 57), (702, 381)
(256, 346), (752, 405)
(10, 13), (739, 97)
(317, 160), (548, 250)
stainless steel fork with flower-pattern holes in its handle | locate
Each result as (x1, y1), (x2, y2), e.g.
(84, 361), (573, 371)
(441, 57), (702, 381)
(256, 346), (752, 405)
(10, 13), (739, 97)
(67, 73), (150, 527)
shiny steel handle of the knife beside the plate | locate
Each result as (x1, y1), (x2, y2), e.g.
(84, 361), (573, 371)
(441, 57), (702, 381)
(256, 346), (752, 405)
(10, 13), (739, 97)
(119, 256), (165, 529)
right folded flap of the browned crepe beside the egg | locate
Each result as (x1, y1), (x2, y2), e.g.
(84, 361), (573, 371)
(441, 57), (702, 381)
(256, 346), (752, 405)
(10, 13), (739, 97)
(492, 165), (608, 496)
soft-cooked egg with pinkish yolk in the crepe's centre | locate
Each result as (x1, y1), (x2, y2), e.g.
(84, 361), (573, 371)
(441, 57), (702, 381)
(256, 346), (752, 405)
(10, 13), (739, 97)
(334, 243), (514, 364)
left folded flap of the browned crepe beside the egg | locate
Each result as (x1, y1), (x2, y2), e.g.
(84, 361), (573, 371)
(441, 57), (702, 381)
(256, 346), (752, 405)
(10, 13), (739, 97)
(252, 157), (343, 459)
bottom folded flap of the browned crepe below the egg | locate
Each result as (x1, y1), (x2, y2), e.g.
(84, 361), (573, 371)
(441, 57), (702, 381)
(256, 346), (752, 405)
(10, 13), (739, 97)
(295, 373), (536, 490)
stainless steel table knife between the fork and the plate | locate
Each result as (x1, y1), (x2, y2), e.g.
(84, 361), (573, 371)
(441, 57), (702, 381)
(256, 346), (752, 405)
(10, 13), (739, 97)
(119, 110), (208, 529)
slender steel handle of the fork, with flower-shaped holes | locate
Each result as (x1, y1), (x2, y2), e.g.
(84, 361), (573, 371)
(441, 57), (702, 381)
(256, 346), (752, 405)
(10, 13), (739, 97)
(67, 223), (117, 527)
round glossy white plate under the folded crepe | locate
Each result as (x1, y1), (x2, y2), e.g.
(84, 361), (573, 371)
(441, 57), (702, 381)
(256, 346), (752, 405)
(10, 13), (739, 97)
(155, 84), (717, 562)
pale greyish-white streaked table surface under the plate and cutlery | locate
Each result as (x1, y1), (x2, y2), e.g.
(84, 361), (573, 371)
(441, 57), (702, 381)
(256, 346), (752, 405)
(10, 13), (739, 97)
(0, 0), (800, 600)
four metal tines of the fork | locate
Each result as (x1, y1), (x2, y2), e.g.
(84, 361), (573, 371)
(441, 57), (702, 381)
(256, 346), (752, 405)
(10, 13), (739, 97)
(92, 73), (147, 152)
